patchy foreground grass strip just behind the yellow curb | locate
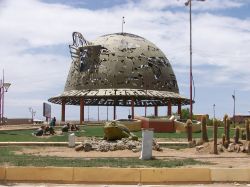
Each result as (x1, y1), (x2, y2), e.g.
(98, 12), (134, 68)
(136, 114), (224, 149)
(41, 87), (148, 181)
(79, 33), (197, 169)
(0, 147), (209, 168)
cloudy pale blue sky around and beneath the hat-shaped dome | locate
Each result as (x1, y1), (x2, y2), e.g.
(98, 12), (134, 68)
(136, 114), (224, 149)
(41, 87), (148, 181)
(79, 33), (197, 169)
(0, 0), (250, 120)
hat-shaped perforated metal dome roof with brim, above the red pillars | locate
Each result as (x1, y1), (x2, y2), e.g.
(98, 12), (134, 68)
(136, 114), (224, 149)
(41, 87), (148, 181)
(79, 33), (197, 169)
(49, 32), (189, 106)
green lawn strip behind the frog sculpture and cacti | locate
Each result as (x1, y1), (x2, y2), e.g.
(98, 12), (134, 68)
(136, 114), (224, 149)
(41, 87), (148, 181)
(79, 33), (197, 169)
(0, 126), (234, 142)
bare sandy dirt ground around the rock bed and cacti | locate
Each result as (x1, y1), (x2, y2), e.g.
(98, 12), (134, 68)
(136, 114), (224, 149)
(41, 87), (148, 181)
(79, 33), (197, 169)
(0, 125), (250, 168)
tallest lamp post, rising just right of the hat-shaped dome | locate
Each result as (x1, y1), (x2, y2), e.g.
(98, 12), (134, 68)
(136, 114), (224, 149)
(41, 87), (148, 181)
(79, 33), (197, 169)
(185, 0), (205, 120)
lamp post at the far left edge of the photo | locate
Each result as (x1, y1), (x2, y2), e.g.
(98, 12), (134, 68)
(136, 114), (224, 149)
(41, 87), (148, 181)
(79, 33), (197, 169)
(0, 70), (11, 124)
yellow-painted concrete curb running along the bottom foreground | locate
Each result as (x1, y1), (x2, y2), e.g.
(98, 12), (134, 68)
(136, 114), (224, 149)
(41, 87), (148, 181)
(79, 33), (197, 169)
(0, 167), (250, 184)
